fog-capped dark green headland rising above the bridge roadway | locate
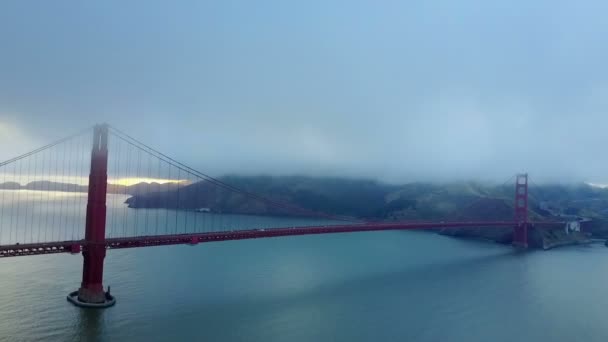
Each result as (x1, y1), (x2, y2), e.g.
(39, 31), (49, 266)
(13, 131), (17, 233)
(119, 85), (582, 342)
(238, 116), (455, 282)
(127, 176), (608, 220)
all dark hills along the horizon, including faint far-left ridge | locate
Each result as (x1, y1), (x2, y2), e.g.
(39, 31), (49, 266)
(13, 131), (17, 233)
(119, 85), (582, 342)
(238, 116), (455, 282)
(0, 176), (608, 248)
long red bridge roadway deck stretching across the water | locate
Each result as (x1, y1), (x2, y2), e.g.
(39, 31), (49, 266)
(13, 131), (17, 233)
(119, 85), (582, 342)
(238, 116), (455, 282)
(0, 221), (565, 258)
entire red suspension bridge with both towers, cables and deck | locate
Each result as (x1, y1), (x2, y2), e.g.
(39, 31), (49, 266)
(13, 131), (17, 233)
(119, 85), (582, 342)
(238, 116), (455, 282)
(0, 125), (561, 307)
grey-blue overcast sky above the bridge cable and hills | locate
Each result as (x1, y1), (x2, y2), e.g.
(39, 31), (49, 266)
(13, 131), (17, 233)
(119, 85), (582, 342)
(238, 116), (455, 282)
(0, 0), (608, 183)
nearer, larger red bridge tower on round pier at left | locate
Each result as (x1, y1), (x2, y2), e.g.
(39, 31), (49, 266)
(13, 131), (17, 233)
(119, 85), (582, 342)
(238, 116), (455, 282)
(68, 124), (115, 307)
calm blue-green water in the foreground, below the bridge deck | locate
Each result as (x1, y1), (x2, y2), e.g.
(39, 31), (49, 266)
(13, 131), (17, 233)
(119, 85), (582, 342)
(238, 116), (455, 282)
(0, 192), (608, 342)
